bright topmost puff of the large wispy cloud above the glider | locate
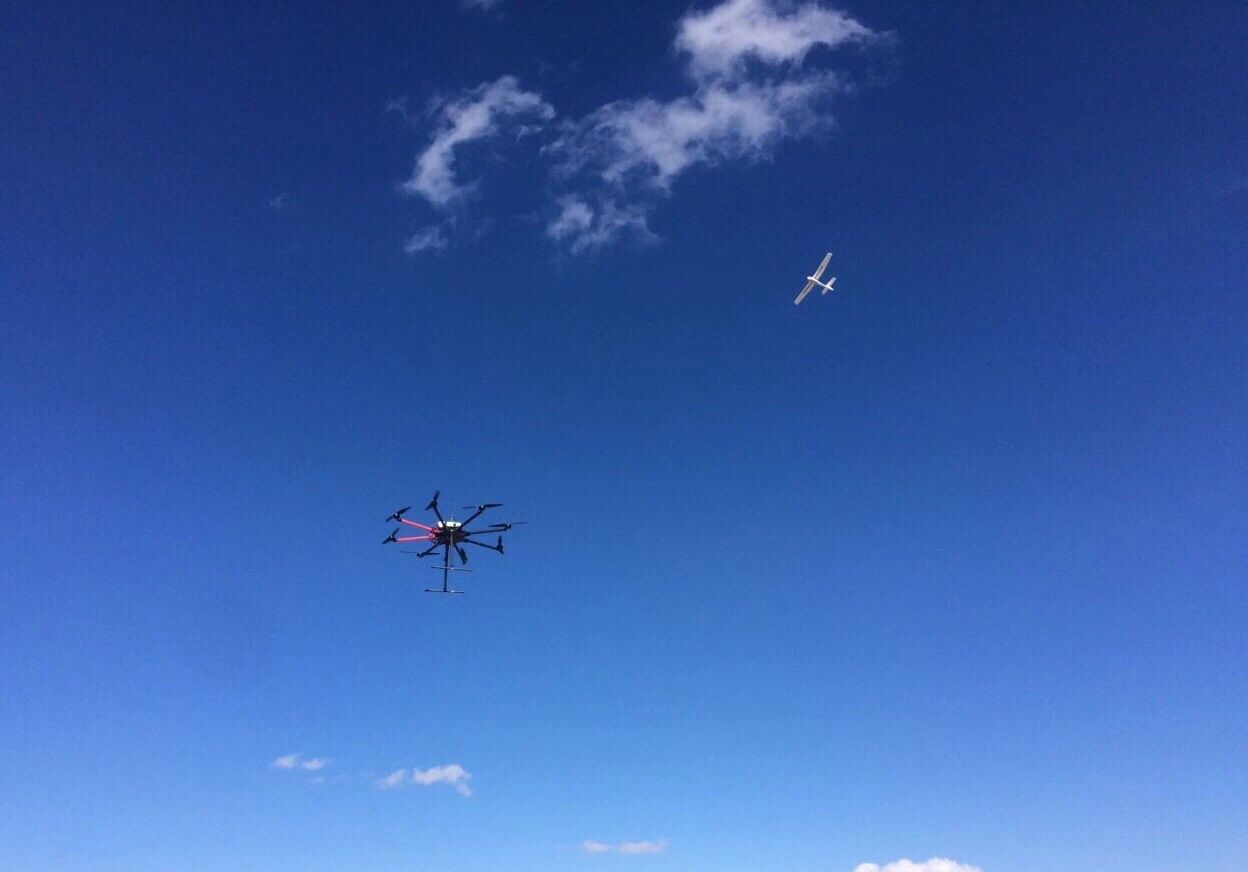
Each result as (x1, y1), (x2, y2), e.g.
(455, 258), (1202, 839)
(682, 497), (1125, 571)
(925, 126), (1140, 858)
(676, 0), (876, 77)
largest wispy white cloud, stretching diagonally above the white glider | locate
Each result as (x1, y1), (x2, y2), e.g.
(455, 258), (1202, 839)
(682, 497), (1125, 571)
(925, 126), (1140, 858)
(545, 0), (876, 253)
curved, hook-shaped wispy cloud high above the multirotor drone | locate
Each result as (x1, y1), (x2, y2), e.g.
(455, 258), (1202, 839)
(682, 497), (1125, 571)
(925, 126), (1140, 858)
(402, 76), (554, 207)
